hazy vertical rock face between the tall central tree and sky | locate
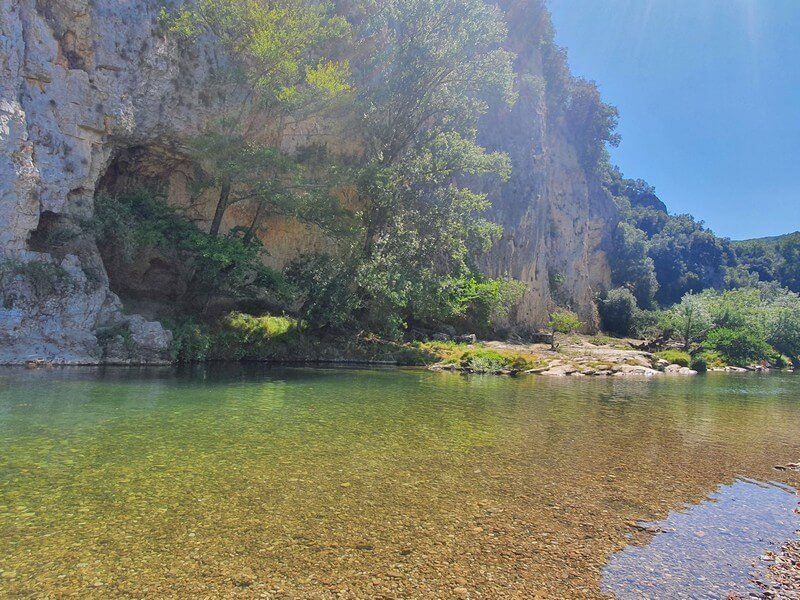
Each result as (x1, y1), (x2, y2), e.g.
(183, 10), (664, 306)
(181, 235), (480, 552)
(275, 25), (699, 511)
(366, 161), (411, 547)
(480, 0), (618, 328)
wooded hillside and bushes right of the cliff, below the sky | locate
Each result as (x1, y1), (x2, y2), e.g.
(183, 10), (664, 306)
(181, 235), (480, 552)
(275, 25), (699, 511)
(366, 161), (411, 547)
(598, 168), (800, 370)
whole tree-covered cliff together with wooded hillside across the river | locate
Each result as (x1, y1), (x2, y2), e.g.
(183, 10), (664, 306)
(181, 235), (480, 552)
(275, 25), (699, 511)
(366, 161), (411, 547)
(0, 0), (800, 365)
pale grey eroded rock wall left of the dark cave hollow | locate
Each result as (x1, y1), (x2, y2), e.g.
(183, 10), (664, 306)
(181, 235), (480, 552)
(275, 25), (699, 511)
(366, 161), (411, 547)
(0, 0), (225, 363)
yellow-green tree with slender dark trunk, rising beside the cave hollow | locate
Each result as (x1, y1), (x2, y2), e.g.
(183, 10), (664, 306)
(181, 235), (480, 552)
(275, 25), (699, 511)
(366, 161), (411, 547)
(163, 0), (349, 236)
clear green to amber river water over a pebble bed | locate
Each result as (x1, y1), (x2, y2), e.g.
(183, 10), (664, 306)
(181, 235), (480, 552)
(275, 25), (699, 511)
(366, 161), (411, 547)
(0, 366), (800, 598)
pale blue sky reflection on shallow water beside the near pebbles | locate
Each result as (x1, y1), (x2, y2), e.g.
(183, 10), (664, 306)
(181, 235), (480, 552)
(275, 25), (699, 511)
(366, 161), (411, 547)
(603, 479), (800, 600)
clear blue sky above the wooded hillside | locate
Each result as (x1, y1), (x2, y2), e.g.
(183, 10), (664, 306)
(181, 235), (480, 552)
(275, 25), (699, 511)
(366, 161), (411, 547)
(549, 0), (800, 239)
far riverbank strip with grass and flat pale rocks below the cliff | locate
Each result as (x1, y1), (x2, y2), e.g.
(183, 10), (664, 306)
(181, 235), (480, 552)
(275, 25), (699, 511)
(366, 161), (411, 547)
(14, 325), (790, 377)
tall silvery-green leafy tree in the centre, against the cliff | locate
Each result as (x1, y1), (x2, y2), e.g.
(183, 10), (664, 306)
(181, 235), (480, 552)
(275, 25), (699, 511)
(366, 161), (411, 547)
(340, 0), (514, 332)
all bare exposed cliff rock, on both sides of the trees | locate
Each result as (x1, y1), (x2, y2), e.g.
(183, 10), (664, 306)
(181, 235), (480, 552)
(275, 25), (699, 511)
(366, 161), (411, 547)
(0, 0), (615, 364)
